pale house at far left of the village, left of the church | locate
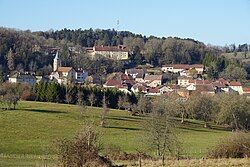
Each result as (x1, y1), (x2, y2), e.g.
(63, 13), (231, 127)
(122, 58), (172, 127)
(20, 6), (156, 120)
(9, 73), (36, 86)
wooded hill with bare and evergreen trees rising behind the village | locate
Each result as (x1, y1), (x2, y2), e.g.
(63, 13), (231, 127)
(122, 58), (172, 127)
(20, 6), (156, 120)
(0, 28), (247, 78)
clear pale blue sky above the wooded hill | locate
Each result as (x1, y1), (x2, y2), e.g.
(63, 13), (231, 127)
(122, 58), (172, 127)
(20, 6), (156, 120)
(0, 0), (250, 46)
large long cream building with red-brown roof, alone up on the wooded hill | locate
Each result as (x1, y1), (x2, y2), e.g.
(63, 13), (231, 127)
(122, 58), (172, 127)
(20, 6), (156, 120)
(89, 45), (128, 60)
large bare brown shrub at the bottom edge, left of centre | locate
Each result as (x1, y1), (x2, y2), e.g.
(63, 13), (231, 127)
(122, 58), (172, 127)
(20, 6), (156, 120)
(56, 127), (111, 167)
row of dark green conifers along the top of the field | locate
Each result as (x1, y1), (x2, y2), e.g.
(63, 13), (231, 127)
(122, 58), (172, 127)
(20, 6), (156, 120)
(31, 82), (137, 109)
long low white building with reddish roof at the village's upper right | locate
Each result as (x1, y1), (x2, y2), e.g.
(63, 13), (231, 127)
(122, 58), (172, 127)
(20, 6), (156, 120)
(161, 64), (204, 74)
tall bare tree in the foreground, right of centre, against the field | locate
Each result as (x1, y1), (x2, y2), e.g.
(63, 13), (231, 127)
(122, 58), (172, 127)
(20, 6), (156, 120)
(144, 98), (180, 165)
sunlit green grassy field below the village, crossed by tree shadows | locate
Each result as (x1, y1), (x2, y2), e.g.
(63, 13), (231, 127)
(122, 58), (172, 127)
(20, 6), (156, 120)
(0, 101), (230, 166)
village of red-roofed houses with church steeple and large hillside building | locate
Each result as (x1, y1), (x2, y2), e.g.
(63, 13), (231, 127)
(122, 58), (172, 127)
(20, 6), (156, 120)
(8, 45), (250, 98)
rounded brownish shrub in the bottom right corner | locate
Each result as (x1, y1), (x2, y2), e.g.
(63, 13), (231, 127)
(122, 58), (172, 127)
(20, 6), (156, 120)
(207, 132), (250, 158)
